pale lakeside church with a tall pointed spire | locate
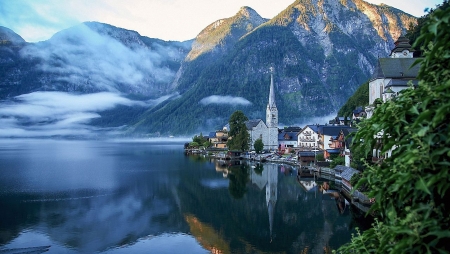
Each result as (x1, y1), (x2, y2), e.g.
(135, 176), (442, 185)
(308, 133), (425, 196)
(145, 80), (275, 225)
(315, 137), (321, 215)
(246, 68), (278, 150)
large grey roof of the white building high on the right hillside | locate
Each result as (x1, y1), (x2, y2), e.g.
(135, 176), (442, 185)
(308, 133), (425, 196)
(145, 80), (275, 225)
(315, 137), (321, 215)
(372, 58), (420, 80)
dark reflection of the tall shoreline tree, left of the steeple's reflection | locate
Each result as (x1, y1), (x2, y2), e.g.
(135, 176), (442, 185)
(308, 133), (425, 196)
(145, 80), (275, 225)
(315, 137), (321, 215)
(228, 163), (250, 199)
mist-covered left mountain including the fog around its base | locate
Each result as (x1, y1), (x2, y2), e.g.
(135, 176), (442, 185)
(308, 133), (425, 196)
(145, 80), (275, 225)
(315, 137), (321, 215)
(0, 22), (192, 136)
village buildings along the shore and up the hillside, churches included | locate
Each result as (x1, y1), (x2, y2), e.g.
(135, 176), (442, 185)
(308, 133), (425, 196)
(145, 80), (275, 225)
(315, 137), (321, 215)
(192, 36), (420, 167)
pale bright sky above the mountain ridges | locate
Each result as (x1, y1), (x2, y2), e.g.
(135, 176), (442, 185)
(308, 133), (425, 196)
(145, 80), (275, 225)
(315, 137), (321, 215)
(0, 0), (443, 42)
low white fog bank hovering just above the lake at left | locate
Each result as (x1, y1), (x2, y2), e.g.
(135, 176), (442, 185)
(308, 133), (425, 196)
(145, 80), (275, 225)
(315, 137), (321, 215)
(0, 92), (149, 137)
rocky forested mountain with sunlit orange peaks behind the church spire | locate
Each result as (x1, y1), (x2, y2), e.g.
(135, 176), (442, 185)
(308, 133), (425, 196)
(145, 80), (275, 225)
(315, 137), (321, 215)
(131, 0), (417, 134)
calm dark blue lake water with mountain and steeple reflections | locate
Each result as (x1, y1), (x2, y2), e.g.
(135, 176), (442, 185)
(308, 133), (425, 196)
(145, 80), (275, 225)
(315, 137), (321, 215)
(0, 140), (368, 253)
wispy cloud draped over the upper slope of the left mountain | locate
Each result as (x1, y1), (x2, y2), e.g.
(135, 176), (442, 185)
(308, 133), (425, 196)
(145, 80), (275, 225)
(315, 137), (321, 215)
(17, 23), (183, 96)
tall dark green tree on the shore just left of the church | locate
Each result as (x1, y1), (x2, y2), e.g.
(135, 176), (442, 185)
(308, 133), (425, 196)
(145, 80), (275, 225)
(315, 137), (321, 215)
(227, 110), (250, 151)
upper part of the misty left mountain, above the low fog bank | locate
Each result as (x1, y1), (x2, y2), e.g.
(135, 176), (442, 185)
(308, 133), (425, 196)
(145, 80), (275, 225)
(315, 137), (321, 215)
(1, 22), (190, 98)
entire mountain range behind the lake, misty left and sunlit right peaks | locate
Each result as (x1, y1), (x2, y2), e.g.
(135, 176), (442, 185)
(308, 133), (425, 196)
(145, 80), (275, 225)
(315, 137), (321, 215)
(0, 0), (417, 137)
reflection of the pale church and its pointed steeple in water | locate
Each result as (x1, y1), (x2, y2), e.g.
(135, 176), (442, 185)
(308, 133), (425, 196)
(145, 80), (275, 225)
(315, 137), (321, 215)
(250, 164), (278, 240)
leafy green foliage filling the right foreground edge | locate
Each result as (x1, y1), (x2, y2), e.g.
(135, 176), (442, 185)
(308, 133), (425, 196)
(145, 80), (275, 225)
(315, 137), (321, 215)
(338, 5), (450, 253)
